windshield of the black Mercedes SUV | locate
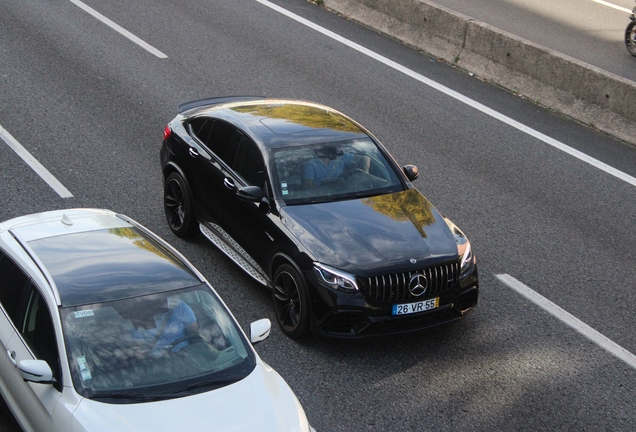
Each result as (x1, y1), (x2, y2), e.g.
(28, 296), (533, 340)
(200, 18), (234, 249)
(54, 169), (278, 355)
(274, 139), (404, 205)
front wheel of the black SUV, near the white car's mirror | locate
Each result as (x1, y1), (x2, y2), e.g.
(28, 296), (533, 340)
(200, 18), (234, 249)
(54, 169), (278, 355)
(273, 264), (309, 339)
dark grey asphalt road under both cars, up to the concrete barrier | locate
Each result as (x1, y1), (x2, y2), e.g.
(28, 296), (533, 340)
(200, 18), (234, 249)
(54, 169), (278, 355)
(0, 0), (636, 432)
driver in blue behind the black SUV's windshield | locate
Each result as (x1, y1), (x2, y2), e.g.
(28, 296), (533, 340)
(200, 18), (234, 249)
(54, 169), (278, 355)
(303, 145), (371, 189)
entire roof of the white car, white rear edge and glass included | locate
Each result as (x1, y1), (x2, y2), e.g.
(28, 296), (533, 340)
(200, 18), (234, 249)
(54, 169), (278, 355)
(0, 209), (202, 306)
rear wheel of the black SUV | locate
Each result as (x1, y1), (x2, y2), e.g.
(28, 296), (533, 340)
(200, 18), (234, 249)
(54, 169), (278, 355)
(163, 172), (197, 237)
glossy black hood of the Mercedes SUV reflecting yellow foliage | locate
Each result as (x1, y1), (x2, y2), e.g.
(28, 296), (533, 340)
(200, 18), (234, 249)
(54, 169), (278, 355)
(282, 189), (458, 274)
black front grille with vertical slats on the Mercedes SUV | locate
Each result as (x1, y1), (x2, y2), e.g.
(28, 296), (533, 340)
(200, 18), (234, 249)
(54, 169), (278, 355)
(358, 262), (459, 302)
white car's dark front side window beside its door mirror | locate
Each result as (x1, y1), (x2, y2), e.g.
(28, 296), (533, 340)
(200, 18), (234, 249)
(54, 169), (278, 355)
(18, 283), (60, 381)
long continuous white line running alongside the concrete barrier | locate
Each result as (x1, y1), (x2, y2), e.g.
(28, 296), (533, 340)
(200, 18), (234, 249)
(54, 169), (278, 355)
(256, 0), (636, 186)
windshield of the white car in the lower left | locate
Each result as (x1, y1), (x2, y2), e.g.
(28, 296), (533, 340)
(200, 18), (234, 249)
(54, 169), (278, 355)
(62, 285), (255, 403)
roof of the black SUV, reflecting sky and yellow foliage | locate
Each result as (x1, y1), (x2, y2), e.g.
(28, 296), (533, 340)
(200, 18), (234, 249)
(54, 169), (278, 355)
(182, 97), (370, 148)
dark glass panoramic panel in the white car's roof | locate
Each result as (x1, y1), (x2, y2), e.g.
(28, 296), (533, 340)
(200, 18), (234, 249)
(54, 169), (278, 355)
(28, 226), (201, 306)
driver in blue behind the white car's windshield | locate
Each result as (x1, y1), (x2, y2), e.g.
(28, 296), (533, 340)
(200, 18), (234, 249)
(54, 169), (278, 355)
(132, 298), (199, 357)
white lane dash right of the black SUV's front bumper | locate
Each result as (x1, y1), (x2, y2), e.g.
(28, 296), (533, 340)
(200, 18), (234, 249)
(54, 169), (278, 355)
(495, 274), (636, 369)
